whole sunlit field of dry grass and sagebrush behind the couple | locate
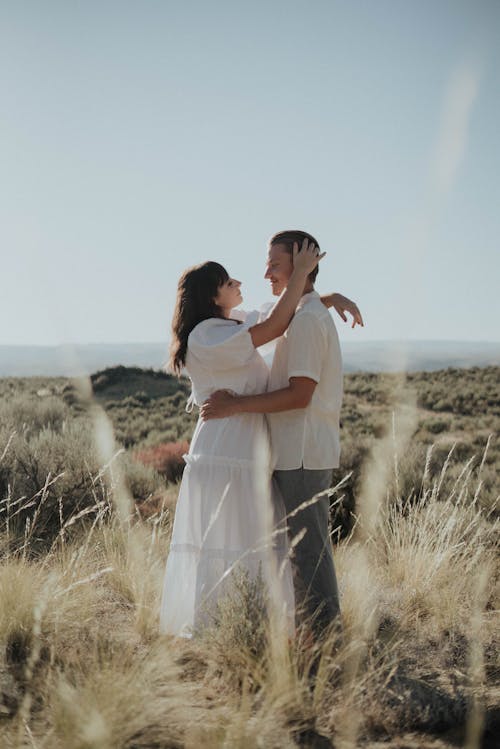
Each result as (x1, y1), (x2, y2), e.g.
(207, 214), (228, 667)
(0, 368), (500, 749)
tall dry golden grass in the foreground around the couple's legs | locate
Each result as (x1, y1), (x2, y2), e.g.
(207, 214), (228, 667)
(0, 400), (499, 749)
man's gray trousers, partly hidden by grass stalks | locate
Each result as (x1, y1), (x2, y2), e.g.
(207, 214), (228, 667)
(273, 468), (340, 635)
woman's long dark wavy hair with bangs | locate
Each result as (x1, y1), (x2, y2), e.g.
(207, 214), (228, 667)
(169, 260), (229, 375)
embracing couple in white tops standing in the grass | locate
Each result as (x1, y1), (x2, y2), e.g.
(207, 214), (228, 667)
(160, 230), (363, 638)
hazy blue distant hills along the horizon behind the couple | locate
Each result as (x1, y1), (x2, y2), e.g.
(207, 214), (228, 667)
(0, 341), (500, 377)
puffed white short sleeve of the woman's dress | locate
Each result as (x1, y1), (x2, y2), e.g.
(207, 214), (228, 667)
(188, 318), (255, 369)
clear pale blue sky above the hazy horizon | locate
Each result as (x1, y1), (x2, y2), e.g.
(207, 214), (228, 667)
(0, 0), (500, 344)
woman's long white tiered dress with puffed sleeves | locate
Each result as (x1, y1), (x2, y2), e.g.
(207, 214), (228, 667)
(160, 312), (294, 636)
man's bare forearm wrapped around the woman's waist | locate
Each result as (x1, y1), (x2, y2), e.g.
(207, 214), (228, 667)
(200, 377), (316, 421)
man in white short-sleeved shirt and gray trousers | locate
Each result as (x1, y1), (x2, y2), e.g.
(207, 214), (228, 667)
(201, 230), (363, 636)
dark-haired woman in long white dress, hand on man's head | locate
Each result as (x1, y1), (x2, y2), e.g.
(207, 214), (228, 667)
(160, 240), (325, 636)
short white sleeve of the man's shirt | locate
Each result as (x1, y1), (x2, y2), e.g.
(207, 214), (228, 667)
(287, 313), (328, 382)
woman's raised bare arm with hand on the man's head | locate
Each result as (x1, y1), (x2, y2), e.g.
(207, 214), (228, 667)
(249, 239), (326, 348)
